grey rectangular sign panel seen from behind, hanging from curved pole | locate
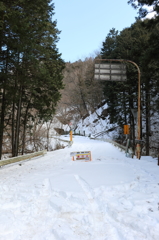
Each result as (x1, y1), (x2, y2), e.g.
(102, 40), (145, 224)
(94, 63), (127, 81)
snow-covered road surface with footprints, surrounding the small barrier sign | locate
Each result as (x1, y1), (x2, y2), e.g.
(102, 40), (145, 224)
(0, 137), (159, 240)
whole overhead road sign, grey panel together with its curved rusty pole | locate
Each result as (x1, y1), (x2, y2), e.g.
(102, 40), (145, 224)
(94, 59), (141, 159)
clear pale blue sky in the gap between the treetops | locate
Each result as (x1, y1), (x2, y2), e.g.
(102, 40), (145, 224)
(53, 0), (137, 62)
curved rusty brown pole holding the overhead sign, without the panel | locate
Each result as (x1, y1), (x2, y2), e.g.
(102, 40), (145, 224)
(96, 59), (141, 159)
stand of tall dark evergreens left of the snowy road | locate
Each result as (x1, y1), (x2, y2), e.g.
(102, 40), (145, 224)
(0, 0), (64, 157)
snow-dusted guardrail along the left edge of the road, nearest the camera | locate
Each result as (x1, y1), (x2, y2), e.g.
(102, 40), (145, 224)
(0, 150), (47, 167)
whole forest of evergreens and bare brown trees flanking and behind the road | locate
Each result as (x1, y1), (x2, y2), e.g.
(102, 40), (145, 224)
(0, 0), (159, 158)
